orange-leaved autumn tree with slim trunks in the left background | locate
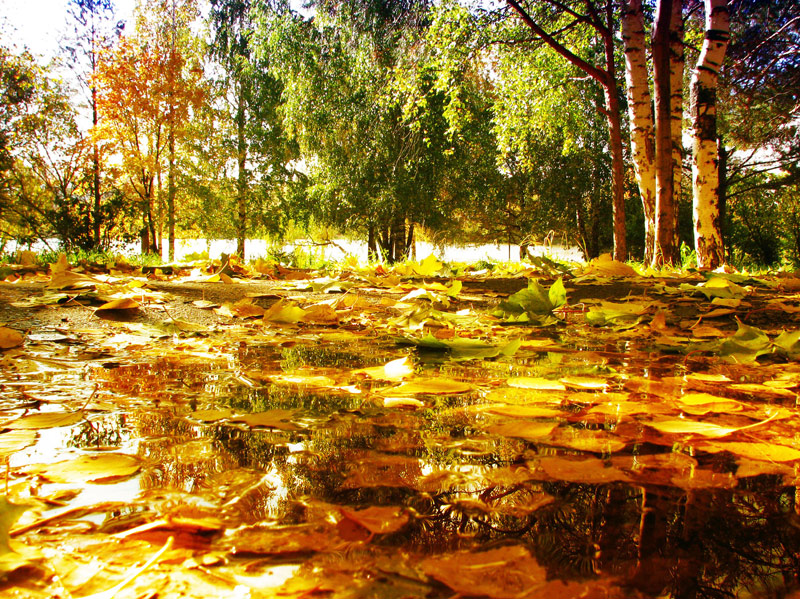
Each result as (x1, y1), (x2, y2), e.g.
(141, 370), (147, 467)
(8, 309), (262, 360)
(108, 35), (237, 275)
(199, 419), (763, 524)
(97, 0), (203, 253)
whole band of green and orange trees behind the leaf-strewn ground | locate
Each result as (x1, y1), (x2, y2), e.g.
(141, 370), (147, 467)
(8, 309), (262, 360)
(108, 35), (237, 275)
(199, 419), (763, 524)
(0, 0), (800, 268)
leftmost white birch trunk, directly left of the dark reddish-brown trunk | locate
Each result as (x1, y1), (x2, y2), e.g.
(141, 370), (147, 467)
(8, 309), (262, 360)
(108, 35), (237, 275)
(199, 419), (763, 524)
(622, 0), (656, 264)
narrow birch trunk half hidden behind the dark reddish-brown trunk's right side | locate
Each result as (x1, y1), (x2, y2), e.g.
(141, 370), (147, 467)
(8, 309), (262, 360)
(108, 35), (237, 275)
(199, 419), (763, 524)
(669, 0), (685, 252)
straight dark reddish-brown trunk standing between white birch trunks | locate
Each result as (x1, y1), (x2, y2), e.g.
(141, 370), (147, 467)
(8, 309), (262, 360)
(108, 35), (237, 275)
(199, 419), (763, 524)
(653, 0), (680, 266)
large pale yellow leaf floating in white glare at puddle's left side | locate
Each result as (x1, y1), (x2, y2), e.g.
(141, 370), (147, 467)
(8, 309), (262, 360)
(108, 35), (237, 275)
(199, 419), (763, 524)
(27, 453), (141, 483)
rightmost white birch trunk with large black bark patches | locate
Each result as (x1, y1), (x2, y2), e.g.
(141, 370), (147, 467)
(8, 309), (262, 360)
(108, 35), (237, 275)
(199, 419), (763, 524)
(689, 0), (730, 270)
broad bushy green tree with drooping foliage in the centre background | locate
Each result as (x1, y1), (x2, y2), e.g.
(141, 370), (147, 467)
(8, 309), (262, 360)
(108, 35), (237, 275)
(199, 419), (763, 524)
(260, 3), (488, 261)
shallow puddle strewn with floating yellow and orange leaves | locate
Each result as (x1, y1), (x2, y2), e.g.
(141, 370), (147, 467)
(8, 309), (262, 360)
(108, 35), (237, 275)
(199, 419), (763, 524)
(2, 330), (800, 598)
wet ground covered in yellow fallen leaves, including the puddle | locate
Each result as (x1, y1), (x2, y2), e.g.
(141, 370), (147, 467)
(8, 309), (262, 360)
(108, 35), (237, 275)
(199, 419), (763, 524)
(0, 257), (800, 599)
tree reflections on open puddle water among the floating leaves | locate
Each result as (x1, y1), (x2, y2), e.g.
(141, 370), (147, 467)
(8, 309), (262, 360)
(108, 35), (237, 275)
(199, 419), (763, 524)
(9, 345), (800, 599)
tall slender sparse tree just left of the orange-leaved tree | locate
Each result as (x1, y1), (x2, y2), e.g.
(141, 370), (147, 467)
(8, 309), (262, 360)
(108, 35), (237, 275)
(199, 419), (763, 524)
(62, 0), (124, 246)
